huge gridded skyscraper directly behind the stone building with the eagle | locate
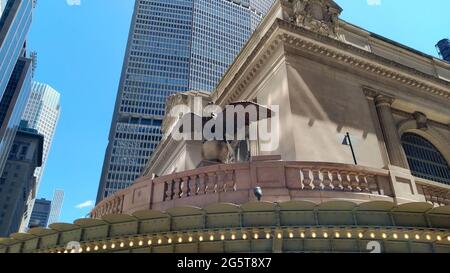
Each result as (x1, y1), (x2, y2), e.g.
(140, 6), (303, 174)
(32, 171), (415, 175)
(97, 0), (273, 202)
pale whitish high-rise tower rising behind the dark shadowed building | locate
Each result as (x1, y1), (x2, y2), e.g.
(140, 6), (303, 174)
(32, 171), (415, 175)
(21, 82), (61, 231)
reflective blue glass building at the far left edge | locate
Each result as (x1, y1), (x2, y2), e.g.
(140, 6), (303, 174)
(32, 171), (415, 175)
(0, 0), (35, 176)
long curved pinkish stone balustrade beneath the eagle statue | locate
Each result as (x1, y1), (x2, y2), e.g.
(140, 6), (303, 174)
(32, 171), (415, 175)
(92, 156), (400, 218)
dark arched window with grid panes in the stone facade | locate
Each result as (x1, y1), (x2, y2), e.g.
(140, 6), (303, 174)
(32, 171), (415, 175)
(402, 133), (450, 185)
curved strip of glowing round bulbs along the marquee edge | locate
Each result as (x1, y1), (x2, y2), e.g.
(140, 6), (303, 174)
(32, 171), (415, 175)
(38, 225), (450, 253)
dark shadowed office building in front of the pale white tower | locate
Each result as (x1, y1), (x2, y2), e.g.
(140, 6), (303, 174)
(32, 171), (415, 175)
(0, 122), (44, 237)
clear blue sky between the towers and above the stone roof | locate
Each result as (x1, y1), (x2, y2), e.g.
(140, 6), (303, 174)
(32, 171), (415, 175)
(29, 0), (450, 222)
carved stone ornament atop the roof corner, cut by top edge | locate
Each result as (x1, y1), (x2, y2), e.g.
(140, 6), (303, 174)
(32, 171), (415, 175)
(293, 0), (342, 37)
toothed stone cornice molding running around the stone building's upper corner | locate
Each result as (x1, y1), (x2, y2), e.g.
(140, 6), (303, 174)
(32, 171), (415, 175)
(213, 18), (450, 103)
